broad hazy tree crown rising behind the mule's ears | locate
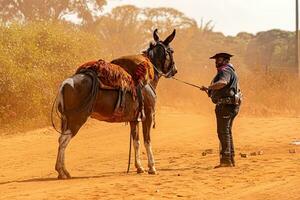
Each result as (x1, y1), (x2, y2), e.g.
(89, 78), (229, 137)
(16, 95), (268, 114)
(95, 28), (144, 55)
(93, 5), (197, 57)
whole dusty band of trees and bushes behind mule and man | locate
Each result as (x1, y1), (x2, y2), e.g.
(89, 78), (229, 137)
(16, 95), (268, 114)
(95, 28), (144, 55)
(0, 0), (300, 133)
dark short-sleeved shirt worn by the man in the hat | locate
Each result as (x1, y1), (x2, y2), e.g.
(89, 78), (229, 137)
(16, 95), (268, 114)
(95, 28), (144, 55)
(209, 64), (239, 103)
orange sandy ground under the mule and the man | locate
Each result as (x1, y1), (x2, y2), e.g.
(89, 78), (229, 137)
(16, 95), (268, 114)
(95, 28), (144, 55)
(0, 112), (300, 200)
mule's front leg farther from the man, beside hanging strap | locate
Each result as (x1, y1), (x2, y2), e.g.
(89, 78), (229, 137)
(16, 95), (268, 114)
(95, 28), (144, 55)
(130, 122), (145, 173)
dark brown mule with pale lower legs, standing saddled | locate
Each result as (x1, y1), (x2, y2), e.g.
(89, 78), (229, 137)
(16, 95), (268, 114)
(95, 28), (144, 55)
(55, 30), (177, 179)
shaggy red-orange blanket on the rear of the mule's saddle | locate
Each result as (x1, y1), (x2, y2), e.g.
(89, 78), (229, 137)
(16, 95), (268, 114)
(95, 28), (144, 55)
(76, 60), (136, 96)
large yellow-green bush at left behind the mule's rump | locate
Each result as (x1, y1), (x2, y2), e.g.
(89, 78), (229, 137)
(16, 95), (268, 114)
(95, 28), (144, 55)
(0, 23), (101, 130)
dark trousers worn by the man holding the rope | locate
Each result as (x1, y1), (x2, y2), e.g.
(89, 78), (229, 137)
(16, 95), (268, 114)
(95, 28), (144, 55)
(215, 104), (239, 164)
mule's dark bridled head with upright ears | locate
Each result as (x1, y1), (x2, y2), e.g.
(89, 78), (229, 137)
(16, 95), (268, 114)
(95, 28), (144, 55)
(146, 29), (177, 78)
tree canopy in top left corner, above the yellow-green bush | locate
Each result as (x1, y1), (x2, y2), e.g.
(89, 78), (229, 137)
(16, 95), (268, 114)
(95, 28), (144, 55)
(0, 0), (106, 23)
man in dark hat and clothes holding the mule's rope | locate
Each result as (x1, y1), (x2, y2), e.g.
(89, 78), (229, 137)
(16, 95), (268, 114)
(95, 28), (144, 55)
(201, 53), (241, 168)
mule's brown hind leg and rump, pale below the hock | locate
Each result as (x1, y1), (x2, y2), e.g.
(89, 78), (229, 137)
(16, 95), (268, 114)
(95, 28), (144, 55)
(55, 74), (94, 179)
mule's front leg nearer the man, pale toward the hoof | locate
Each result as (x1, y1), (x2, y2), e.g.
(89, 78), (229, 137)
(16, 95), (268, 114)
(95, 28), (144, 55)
(143, 114), (157, 174)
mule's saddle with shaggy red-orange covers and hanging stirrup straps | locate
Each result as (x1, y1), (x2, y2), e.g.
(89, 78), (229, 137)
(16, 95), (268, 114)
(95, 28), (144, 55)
(76, 54), (154, 119)
